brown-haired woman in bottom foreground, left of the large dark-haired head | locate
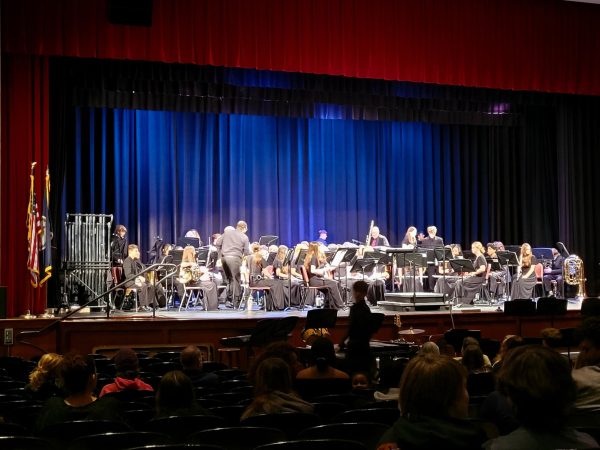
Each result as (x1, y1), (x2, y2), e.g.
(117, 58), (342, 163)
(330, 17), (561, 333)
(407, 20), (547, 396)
(378, 354), (488, 450)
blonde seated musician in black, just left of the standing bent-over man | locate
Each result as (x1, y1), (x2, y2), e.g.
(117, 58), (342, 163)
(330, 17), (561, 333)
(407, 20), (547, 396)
(175, 245), (219, 311)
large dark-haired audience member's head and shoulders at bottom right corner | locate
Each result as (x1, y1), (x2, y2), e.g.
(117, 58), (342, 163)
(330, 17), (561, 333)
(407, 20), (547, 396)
(484, 345), (598, 450)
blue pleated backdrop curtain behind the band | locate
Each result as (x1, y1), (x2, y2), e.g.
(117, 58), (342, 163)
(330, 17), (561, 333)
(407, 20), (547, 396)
(63, 108), (510, 256)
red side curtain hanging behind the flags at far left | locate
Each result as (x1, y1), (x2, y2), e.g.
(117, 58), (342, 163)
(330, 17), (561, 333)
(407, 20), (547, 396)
(0, 56), (49, 317)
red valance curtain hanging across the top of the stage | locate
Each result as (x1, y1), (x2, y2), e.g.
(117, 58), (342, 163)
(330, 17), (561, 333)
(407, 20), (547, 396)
(2, 0), (600, 95)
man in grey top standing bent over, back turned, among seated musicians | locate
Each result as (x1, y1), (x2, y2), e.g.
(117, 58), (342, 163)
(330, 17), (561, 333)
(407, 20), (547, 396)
(215, 229), (250, 307)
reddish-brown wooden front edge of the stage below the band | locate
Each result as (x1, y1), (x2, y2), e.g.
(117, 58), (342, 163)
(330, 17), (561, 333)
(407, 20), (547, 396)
(0, 303), (581, 359)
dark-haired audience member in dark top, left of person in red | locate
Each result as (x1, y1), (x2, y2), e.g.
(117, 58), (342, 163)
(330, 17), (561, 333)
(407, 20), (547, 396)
(36, 354), (122, 431)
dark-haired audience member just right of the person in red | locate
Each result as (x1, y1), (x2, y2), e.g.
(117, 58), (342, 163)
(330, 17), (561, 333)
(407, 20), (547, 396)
(156, 370), (210, 418)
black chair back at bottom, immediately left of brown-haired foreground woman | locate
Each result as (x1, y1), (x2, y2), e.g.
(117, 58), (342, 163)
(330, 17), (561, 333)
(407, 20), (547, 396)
(298, 422), (389, 450)
